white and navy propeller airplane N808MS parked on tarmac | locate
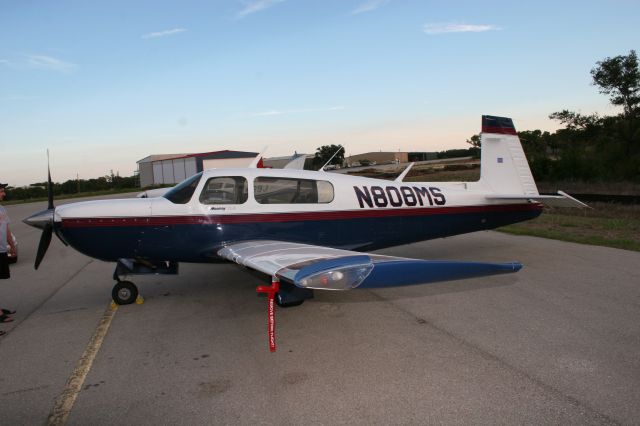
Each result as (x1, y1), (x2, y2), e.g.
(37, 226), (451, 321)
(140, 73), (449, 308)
(24, 115), (585, 350)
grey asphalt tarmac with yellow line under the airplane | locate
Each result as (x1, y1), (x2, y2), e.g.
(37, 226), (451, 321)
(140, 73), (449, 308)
(0, 198), (640, 426)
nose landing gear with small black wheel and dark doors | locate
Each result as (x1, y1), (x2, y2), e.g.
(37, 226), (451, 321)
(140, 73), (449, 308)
(111, 259), (178, 305)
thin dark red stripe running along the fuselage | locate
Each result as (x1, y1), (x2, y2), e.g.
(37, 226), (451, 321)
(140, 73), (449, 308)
(62, 203), (542, 228)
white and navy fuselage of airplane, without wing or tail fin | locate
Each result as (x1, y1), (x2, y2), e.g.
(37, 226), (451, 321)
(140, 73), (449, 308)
(54, 169), (542, 262)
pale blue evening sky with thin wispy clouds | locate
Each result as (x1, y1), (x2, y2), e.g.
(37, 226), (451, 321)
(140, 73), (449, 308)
(0, 0), (640, 186)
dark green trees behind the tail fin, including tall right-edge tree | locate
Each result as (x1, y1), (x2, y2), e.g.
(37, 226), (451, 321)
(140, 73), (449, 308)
(500, 50), (640, 182)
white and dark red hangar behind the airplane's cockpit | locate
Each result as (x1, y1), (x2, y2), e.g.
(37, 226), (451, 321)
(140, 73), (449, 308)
(137, 150), (262, 188)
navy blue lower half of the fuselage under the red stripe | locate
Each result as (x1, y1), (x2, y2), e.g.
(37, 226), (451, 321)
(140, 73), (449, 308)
(56, 208), (542, 262)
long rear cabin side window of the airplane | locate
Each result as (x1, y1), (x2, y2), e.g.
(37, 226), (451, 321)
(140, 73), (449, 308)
(253, 177), (333, 204)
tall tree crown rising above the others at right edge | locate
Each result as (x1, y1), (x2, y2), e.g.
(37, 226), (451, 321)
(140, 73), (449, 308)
(591, 50), (640, 118)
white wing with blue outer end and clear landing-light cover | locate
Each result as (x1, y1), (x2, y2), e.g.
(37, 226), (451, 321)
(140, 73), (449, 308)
(218, 241), (522, 290)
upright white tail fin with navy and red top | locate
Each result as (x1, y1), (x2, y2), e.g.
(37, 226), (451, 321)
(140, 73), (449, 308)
(480, 115), (539, 197)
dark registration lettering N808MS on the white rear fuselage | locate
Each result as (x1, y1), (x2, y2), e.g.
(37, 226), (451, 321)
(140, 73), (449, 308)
(353, 186), (447, 209)
